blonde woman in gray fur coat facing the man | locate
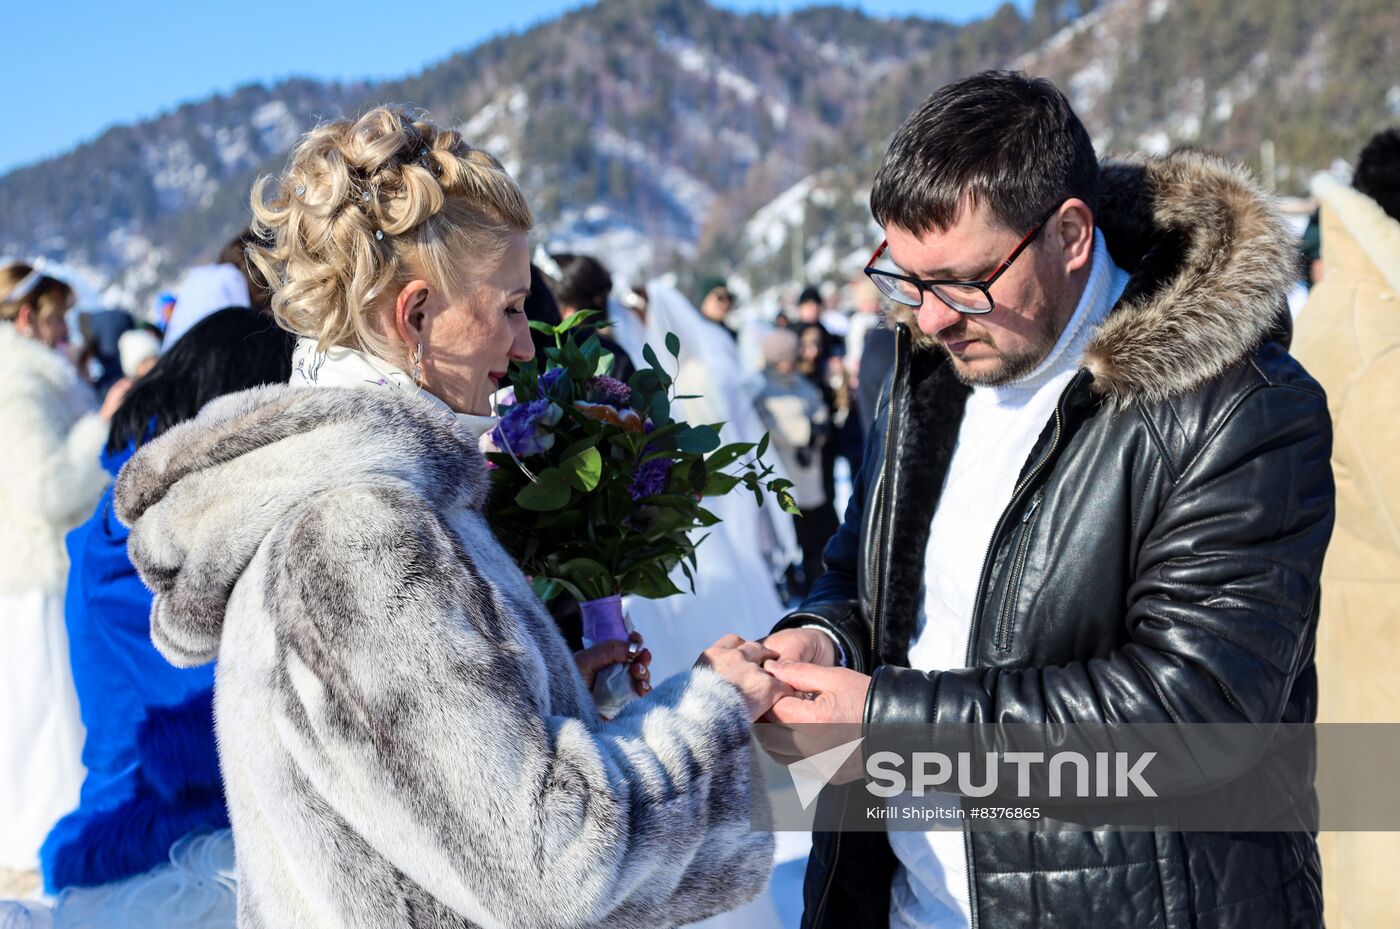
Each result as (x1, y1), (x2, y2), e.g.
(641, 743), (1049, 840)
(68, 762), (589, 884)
(116, 108), (791, 929)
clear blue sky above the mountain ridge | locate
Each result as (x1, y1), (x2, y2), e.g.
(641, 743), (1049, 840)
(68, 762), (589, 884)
(0, 0), (1024, 173)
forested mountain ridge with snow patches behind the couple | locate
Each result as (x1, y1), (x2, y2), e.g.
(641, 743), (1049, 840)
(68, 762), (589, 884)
(0, 0), (1400, 313)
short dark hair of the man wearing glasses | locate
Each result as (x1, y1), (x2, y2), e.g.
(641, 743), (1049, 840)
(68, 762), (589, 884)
(871, 71), (1099, 235)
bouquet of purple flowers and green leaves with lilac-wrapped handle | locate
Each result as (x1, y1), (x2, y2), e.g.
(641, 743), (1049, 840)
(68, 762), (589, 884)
(482, 311), (798, 715)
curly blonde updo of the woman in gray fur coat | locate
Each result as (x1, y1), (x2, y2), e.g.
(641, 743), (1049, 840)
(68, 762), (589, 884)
(249, 106), (533, 362)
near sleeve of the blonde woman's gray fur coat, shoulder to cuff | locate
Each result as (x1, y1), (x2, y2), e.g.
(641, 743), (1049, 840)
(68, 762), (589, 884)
(263, 484), (773, 928)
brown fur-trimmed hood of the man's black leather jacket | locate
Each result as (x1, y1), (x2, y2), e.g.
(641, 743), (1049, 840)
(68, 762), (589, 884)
(897, 151), (1296, 407)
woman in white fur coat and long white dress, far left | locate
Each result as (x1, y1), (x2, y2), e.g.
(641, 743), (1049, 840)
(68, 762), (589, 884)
(0, 263), (123, 895)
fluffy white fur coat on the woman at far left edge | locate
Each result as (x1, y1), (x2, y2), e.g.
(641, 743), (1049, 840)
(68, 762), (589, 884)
(0, 322), (108, 595)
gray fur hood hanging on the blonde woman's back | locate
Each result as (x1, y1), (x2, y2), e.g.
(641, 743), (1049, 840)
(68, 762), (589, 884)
(116, 386), (487, 666)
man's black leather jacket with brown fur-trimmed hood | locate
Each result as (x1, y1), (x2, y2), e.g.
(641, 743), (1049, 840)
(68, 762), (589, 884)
(778, 155), (1333, 929)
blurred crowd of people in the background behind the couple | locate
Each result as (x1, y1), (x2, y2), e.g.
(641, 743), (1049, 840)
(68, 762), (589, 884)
(0, 81), (1400, 925)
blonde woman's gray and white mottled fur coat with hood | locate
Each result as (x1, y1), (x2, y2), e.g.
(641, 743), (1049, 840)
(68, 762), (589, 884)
(118, 388), (773, 929)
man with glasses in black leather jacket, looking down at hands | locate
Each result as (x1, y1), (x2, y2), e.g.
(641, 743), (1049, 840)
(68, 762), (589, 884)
(766, 73), (1333, 929)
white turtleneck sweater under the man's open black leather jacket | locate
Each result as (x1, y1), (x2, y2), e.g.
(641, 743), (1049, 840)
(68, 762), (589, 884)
(889, 232), (1128, 929)
